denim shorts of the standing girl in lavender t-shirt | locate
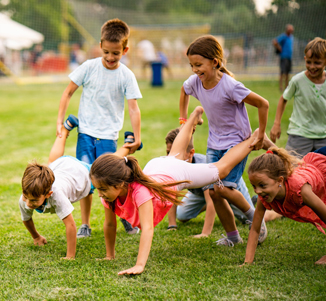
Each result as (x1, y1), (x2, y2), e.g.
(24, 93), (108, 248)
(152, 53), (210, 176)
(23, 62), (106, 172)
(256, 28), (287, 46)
(206, 148), (248, 189)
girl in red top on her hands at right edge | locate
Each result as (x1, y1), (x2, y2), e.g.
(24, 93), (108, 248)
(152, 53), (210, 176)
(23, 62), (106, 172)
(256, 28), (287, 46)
(245, 147), (326, 264)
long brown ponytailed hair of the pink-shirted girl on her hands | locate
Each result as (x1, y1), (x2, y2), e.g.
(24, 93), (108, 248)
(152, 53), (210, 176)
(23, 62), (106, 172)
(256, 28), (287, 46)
(90, 154), (190, 205)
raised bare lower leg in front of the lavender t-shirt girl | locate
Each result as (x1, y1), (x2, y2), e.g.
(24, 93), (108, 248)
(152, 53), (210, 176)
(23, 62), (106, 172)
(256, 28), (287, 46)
(169, 107), (204, 160)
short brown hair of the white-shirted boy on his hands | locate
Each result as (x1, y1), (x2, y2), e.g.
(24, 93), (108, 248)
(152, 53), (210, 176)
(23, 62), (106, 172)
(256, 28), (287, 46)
(22, 162), (55, 198)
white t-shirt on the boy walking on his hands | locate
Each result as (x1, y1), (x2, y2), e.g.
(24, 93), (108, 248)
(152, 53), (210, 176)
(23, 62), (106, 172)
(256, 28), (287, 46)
(19, 157), (91, 221)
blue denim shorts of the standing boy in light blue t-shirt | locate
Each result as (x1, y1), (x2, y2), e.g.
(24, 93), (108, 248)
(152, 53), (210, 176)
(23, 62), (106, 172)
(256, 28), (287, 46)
(76, 133), (117, 164)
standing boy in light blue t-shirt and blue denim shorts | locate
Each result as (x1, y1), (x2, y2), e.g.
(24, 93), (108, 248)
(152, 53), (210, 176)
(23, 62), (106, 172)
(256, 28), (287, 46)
(57, 19), (142, 236)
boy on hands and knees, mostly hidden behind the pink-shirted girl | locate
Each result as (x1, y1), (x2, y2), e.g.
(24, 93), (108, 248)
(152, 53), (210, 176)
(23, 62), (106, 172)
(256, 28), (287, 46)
(165, 128), (254, 234)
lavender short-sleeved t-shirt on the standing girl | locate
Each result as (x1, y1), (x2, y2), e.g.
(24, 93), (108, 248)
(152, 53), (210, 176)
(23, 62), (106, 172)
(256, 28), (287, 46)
(183, 73), (251, 150)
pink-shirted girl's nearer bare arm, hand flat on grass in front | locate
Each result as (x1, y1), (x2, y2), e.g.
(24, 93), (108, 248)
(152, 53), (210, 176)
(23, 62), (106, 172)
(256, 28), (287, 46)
(118, 200), (154, 275)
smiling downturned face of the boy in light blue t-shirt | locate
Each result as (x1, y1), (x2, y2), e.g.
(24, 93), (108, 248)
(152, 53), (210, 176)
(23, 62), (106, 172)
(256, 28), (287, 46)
(100, 41), (129, 70)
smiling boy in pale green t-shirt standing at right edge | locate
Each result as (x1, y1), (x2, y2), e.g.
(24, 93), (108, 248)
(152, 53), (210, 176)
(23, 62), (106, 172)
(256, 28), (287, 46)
(270, 38), (326, 157)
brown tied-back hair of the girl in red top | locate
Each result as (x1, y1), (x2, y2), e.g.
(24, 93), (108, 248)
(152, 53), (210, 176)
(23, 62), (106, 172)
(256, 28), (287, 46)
(248, 147), (302, 180)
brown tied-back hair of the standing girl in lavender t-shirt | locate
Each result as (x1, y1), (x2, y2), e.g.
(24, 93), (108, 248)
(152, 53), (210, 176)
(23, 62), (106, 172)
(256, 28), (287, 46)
(187, 35), (233, 77)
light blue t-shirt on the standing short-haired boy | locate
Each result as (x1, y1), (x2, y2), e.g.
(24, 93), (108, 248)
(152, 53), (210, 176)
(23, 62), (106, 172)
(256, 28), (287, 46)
(69, 57), (142, 140)
